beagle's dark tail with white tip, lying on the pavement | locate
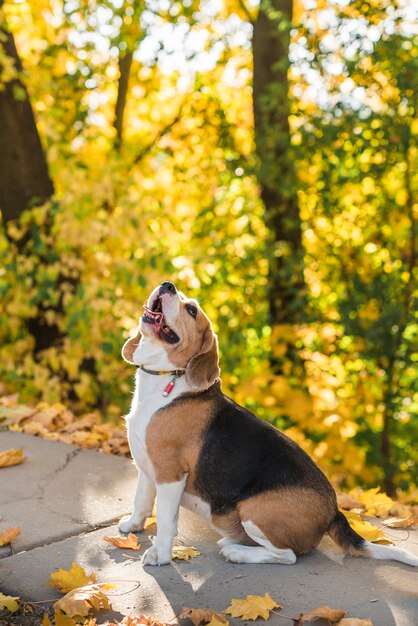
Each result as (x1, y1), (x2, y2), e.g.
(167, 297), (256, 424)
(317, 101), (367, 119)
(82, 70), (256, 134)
(328, 511), (418, 567)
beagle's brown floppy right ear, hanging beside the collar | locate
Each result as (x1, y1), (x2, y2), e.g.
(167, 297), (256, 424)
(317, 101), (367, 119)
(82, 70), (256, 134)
(185, 326), (221, 391)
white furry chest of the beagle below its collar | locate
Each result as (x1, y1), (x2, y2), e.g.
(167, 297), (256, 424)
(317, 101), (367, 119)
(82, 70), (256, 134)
(126, 371), (187, 483)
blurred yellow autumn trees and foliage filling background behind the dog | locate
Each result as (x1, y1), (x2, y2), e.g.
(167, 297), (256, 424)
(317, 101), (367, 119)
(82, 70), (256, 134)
(0, 0), (418, 495)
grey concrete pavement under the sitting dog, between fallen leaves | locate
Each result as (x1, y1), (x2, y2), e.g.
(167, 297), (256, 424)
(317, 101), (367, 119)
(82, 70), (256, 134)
(0, 432), (418, 626)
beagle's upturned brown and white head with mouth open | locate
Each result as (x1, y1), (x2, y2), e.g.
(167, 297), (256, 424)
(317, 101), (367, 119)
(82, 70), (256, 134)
(122, 281), (220, 390)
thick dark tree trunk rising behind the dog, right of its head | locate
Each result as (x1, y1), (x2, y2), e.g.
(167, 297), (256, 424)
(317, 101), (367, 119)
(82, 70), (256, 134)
(253, 0), (306, 326)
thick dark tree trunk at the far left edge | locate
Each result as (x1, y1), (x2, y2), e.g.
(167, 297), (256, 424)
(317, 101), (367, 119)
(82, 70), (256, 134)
(0, 18), (54, 224)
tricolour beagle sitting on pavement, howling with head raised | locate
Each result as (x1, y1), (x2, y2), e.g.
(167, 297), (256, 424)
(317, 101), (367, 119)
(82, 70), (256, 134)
(119, 281), (418, 566)
